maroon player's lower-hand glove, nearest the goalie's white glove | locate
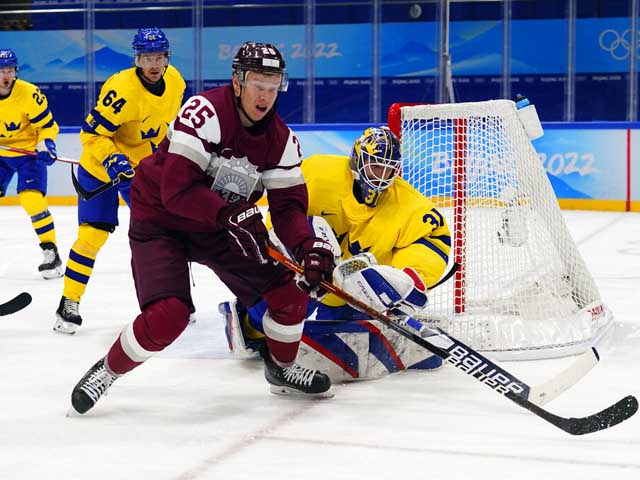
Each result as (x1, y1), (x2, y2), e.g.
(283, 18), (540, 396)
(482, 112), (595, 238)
(296, 237), (335, 300)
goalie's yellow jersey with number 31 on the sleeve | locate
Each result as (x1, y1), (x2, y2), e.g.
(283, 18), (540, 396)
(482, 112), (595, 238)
(302, 155), (451, 306)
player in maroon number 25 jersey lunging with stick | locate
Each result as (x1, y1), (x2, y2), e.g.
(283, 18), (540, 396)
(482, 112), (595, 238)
(71, 42), (334, 413)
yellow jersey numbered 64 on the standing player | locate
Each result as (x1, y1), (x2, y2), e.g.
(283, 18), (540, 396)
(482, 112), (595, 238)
(80, 65), (186, 182)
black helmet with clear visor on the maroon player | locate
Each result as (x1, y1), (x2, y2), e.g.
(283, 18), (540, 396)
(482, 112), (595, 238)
(231, 42), (289, 92)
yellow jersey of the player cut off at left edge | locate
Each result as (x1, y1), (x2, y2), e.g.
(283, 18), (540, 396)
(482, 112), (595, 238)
(0, 78), (59, 157)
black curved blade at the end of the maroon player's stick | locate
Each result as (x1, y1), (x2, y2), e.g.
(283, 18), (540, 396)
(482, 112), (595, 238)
(506, 392), (638, 435)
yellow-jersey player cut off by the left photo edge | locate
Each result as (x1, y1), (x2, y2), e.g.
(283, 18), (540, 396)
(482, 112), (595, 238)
(0, 49), (62, 279)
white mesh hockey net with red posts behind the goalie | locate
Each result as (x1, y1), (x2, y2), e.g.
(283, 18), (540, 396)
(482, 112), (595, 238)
(389, 100), (613, 360)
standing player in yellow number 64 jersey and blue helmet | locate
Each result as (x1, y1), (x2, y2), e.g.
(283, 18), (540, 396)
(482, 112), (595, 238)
(53, 28), (186, 334)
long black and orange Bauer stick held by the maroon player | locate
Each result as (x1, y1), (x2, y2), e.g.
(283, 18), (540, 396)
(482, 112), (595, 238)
(267, 247), (638, 435)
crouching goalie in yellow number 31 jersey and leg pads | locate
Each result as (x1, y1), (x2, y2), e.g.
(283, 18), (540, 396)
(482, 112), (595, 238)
(220, 127), (451, 382)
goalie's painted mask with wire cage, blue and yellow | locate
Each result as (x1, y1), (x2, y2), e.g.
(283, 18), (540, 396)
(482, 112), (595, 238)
(349, 127), (402, 207)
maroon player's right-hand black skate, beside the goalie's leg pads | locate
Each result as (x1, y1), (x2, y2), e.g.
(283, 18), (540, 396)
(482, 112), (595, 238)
(260, 343), (333, 398)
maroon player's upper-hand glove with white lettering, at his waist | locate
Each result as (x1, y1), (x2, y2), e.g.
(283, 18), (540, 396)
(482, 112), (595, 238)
(217, 201), (269, 265)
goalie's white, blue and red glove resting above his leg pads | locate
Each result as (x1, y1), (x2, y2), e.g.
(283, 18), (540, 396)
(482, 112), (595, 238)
(335, 254), (427, 316)
